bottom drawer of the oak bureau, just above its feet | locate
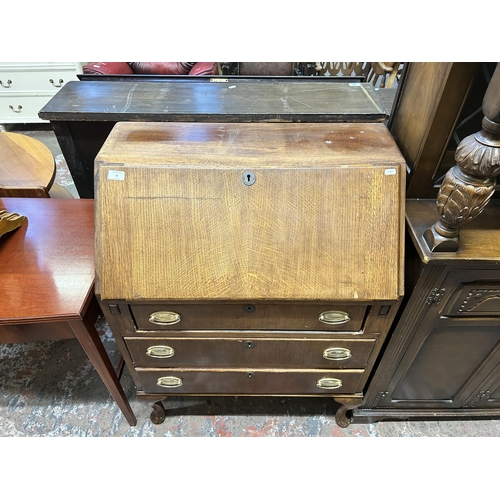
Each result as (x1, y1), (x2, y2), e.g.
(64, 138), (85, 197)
(136, 368), (364, 395)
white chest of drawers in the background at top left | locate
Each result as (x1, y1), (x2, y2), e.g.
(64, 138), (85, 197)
(0, 62), (82, 127)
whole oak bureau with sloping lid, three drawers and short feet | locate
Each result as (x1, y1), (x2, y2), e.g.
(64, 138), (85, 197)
(95, 122), (406, 427)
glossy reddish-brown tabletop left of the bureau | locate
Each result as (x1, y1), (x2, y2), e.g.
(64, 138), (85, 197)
(0, 197), (94, 325)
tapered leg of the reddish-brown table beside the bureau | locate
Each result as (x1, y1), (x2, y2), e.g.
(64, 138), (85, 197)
(68, 304), (137, 425)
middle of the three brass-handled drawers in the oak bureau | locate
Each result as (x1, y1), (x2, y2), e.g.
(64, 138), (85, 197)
(124, 337), (375, 368)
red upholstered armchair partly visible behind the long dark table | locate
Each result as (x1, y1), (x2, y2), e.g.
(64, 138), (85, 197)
(83, 62), (218, 75)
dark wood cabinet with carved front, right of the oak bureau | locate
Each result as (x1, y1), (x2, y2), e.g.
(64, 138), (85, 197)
(354, 200), (500, 422)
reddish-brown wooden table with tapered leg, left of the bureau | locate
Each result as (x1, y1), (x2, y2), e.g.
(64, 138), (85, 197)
(0, 198), (137, 425)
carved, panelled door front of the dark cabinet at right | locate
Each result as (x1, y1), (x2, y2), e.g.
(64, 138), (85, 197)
(377, 269), (500, 408)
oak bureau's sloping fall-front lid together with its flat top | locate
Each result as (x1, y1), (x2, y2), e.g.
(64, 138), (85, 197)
(95, 122), (405, 301)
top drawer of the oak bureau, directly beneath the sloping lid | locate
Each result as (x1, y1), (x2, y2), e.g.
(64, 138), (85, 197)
(131, 303), (366, 331)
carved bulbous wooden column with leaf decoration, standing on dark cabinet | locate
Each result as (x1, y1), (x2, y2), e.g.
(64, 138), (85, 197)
(424, 63), (500, 252)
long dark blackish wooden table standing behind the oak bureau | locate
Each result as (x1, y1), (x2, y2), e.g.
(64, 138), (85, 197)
(39, 75), (388, 198)
